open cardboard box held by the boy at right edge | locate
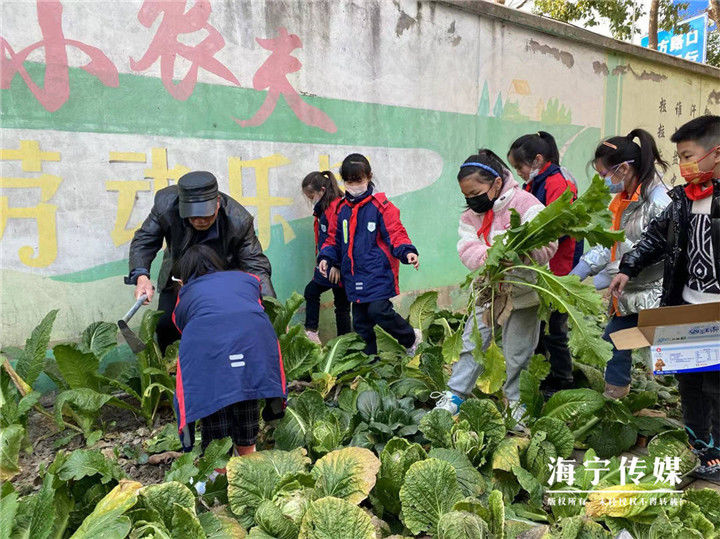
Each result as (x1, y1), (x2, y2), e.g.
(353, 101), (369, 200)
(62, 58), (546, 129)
(610, 302), (720, 374)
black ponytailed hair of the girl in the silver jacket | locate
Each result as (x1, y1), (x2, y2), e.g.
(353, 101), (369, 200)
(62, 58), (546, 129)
(594, 129), (668, 198)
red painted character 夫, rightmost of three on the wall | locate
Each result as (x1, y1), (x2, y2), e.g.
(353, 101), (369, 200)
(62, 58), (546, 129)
(235, 28), (337, 133)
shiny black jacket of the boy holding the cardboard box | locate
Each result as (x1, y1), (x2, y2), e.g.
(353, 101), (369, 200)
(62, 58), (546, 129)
(619, 180), (720, 306)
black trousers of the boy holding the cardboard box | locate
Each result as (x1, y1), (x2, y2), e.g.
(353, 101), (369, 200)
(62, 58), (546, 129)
(675, 371), (720, 447)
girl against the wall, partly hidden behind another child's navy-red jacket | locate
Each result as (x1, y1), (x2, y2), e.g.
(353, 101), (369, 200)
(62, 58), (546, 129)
(302, 170), (350, 344)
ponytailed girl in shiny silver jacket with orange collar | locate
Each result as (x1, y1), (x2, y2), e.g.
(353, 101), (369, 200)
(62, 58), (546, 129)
(571, 129), (670, 399)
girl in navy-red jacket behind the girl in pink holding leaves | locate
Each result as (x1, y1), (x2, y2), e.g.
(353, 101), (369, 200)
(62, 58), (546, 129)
(508, 131), (583, 393)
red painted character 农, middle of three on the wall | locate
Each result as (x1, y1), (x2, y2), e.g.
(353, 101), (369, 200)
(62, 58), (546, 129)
(130, 0), (240, 101)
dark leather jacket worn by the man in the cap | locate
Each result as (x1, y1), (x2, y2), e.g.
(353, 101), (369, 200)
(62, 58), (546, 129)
(130, 185), (275, 297)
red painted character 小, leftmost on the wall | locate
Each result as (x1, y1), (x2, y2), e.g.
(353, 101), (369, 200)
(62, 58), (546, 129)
(0, 0), (119, 112)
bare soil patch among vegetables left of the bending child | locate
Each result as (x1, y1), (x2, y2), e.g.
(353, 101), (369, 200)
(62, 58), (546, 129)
(11, 396), (175, 494)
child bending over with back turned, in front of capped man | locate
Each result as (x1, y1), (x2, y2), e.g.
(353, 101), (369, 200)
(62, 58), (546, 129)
(172, 244), (286, 455)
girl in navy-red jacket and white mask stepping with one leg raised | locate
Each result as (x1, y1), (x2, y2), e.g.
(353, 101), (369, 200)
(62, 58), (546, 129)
(318, 153), (422, 354)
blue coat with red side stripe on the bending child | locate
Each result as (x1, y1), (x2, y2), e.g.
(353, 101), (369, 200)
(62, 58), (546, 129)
(173, 271), (286, 431)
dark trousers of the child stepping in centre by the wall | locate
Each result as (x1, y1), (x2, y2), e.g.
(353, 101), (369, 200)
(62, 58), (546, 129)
(353, 299), (415, 355)
